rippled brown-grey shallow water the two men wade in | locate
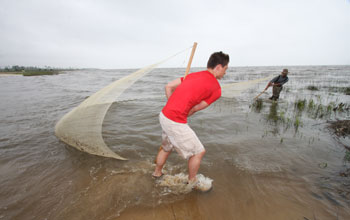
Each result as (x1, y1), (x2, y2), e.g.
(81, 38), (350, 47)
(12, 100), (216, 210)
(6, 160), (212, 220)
(0, 66), (350, 219)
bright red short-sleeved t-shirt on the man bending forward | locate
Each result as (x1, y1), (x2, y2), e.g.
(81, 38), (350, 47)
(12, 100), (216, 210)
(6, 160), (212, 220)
(162, 71), (221, 123)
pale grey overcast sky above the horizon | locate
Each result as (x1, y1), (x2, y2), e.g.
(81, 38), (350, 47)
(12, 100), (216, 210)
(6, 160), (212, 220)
(0, 0), (350, 68)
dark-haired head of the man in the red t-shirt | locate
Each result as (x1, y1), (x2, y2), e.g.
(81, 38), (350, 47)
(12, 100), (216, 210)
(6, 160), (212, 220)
(207, 51), (230, 79)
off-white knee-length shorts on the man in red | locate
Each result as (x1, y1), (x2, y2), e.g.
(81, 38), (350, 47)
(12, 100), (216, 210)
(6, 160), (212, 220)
(159, 112), (205, 160)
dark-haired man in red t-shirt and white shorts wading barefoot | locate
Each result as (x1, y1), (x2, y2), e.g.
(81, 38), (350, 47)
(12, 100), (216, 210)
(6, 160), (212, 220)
(152, 52), (229, 187)
